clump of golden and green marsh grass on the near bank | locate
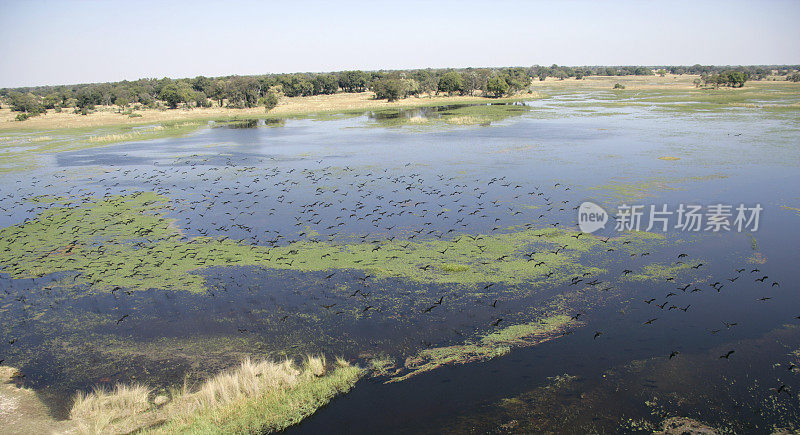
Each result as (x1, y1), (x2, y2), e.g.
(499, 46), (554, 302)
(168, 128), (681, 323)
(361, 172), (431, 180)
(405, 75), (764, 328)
(70, 355), (362, 433)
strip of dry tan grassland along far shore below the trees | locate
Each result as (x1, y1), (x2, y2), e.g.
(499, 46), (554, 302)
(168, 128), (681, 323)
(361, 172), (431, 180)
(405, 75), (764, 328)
(0, 74), (800, 134)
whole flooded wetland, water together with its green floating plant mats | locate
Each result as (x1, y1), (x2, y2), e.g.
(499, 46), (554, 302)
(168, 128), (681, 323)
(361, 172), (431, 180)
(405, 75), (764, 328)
(0, 97), (800, 433)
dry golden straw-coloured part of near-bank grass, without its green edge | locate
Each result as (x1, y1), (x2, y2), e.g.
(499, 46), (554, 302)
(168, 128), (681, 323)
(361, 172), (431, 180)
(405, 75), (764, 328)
(70, 355), (360, 434)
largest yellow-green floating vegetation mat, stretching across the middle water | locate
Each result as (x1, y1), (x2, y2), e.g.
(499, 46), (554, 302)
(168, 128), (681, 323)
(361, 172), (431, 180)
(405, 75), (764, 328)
(0, 192), (668, 292)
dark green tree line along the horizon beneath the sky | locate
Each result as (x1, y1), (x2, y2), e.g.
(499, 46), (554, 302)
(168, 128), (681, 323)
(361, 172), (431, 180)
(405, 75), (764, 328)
(0, 65), (798, 119)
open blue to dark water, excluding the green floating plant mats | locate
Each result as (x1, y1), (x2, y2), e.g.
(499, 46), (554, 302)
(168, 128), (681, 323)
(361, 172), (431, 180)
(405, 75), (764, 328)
(0, 102), (800, 433)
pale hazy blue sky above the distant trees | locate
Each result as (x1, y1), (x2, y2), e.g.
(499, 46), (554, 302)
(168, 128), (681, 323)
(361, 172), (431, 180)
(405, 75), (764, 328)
(0, 0), (800, 88)
